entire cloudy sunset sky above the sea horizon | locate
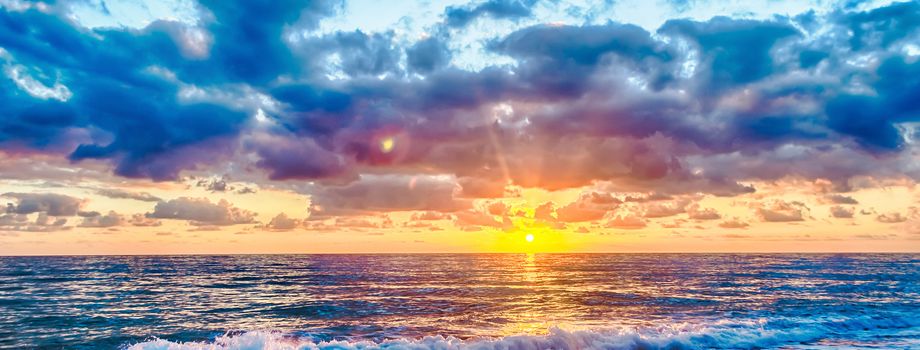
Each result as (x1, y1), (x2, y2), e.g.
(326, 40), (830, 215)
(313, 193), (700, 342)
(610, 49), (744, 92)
(0, 0), (920, 255)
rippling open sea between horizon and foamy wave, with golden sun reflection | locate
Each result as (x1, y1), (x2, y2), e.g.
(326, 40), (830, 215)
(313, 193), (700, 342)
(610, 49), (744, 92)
(0, 254), (916, 348)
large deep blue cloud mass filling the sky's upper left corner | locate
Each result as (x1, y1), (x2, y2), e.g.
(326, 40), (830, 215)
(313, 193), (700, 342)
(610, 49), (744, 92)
(0, 2), (332, 180)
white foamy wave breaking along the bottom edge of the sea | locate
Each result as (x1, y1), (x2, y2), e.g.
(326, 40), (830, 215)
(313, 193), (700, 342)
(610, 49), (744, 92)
(127, 317), (920, 350)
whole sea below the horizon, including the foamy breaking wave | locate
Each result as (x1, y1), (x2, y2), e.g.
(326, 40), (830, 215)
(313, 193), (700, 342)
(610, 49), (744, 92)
(0, 254), (920, 350)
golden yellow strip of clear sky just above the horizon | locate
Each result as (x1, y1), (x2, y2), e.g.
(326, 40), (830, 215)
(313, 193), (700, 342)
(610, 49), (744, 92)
(0, 178), (920, 255)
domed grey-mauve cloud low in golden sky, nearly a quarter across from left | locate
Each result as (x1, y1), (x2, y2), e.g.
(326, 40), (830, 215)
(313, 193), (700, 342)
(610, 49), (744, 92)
(146, 197), (255, 226)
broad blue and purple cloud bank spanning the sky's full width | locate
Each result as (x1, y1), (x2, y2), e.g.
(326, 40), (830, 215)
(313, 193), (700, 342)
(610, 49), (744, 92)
(0, 1), (920, 194)
